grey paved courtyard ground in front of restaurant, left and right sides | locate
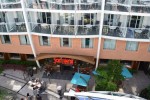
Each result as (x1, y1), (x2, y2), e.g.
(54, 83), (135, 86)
(0, 70), (150, 100)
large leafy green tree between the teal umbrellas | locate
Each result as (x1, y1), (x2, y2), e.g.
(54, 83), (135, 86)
(95, 60), (124, 91)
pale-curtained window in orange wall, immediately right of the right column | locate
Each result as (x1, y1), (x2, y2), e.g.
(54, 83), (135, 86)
(103, 39), (116, 50)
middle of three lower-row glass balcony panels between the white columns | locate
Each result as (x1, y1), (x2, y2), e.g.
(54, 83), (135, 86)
(53, 25), (75, 35)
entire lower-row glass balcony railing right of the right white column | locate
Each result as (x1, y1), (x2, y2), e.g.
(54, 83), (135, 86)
(102, 25), (150, 39)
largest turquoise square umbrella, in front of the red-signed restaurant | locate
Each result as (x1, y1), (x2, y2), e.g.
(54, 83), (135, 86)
(71, 73), (90, 86)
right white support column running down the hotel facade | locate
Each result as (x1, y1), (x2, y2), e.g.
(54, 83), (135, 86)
(95, 0), (105, 70)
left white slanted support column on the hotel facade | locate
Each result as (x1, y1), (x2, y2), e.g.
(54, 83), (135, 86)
(21, 0), (41, 67)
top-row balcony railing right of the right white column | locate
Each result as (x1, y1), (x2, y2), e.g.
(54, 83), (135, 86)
(105, 0), (150, 13)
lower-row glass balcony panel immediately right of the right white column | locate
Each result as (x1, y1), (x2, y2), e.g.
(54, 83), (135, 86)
(102, 25), (126, 37)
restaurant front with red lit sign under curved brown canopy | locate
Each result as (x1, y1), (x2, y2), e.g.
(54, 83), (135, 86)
(36, 54), (95, 73)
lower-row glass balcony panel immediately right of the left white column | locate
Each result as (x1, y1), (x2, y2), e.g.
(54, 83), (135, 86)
(30, 23), (51, 34)
